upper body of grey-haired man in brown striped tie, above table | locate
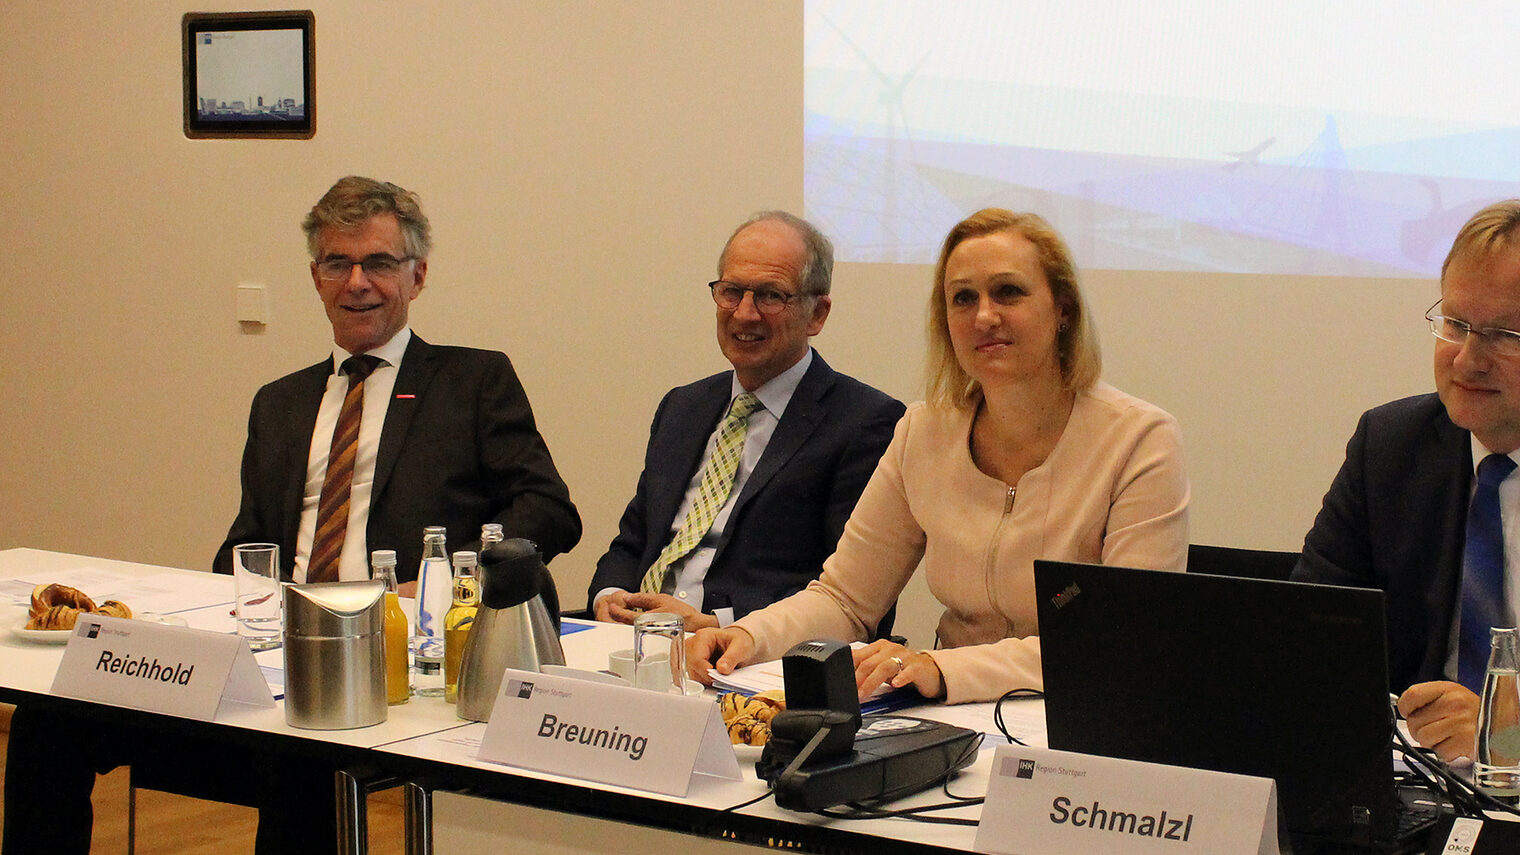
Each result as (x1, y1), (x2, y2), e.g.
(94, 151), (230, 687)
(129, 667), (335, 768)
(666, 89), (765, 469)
(214, 176), (581, 584)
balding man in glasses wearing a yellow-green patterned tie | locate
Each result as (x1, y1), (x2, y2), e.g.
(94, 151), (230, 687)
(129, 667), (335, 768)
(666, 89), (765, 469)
(588, 211), (903, 633)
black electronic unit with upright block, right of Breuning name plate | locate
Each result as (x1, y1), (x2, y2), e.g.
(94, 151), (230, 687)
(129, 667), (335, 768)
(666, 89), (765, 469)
(755, 640), (979, 811)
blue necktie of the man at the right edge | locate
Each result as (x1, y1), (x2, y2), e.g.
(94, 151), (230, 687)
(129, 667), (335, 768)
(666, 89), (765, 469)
(1456, 455), (1515, 694)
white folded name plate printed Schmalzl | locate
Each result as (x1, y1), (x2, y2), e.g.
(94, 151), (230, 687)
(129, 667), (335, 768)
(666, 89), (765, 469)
(976, 745), (1277, 855)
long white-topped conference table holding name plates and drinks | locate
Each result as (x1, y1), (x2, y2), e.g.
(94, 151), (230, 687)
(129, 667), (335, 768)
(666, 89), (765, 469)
(0, 548), (1044, 853)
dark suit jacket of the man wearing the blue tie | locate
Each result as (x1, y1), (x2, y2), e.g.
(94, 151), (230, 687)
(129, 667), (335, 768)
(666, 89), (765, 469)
(1292, 394), (1473, 692)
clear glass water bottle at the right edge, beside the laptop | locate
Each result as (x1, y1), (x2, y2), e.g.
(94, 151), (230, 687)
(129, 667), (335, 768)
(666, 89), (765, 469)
(1473, 617), (1520, 805)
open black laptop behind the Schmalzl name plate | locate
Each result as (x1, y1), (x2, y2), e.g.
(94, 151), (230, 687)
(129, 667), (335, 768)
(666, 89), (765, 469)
(1035, 561), (1436, 852)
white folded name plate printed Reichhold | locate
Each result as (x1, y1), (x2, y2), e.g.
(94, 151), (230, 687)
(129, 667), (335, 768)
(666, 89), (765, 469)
(52, 615), (275, 721)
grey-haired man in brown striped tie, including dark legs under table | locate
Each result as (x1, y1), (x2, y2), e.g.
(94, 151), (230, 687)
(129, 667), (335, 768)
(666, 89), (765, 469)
(3, 176), (581, 855)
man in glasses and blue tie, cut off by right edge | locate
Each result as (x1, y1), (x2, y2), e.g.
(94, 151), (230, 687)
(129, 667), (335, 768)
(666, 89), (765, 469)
(1294, 199), (1520, 758)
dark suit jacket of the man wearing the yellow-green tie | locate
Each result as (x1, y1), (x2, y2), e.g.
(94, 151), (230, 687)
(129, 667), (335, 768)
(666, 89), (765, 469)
(588, 351), (903, 618)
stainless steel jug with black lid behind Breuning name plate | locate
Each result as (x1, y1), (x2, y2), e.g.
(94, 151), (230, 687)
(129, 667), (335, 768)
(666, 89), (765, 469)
(458, 537), (565, 721)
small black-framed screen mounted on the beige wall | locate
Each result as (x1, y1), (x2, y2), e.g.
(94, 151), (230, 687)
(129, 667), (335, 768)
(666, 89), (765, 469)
(182, 11), (316, 140)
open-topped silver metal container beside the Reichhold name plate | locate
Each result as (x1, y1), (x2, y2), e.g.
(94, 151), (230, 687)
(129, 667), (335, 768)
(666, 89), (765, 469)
(284, 581), (386, 730)
